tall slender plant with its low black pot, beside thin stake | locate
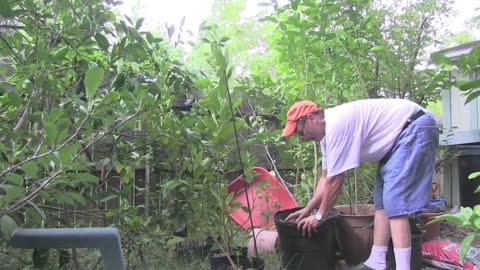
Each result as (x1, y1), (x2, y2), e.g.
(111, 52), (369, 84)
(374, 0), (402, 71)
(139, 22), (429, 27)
(180, 31), (264, 270)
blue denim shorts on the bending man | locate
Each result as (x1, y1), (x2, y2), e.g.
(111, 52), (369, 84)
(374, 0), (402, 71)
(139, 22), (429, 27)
(373, 113), (439, 217)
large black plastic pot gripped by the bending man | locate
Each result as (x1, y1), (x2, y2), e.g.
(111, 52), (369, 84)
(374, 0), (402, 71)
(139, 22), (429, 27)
(274, 208), (338, 270)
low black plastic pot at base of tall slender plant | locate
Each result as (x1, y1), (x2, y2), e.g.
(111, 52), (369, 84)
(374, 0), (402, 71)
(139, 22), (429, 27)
(208, 252), (265, 270)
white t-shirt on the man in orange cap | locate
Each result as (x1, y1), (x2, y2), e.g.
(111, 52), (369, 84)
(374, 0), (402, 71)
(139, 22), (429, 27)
(320, 99), (423, 176)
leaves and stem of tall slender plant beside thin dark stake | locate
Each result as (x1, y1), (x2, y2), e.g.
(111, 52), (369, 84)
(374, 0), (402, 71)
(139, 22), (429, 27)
(188, 31), (251, 260)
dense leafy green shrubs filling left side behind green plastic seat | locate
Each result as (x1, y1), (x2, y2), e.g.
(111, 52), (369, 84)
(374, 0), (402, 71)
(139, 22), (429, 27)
(0, 0), (207, 266)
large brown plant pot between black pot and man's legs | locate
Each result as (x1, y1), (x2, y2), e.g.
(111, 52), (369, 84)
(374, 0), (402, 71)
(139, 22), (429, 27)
(334, 204), (375, 265)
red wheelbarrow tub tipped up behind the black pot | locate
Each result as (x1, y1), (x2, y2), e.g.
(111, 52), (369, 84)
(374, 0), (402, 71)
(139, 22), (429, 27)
(227, 167), (298, 229)
